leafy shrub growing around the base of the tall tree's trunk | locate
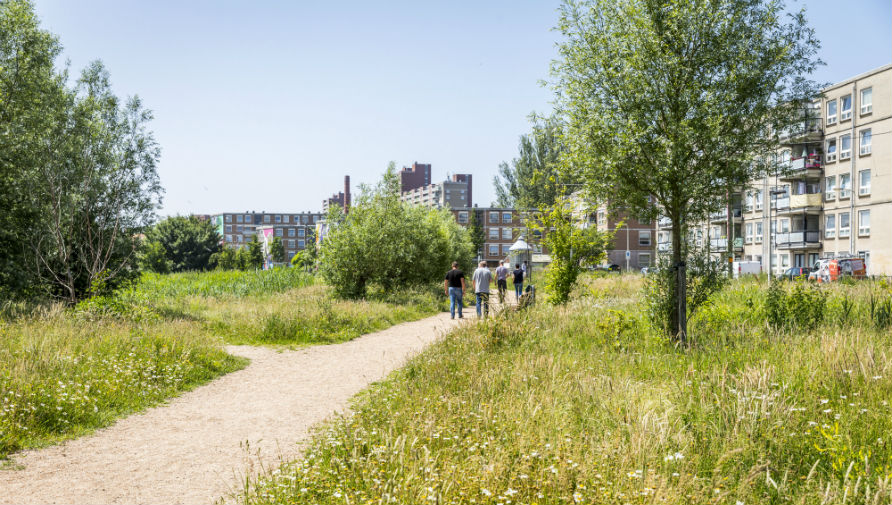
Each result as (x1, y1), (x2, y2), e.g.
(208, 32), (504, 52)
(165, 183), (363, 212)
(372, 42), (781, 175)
(642, 250), (728, 336)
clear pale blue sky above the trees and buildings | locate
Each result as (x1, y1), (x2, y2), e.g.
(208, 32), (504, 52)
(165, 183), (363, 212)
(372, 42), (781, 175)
(35, 0), (892, 214)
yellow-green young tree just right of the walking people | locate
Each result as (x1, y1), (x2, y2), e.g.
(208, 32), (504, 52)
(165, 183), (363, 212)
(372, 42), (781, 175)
(532, 198), (613, 305)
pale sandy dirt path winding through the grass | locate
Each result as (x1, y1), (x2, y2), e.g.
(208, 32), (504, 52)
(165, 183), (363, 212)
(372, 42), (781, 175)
(0, 309), (460, 504)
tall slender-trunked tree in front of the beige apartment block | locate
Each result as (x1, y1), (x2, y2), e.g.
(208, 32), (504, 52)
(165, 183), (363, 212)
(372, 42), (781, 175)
(552, 0), (818, 342)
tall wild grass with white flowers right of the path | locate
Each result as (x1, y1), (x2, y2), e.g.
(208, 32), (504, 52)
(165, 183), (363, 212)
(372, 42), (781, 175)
(242, 276), (892, 505)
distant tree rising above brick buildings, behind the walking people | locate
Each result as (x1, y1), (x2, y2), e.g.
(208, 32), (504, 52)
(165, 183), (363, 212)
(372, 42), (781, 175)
(493, 117), (576, 209)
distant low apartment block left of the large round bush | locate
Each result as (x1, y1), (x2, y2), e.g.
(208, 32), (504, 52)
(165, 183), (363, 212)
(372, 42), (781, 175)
(213, 212), (323, 258)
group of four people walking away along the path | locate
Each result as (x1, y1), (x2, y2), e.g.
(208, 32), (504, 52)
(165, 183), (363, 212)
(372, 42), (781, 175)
(444, 261), (527, 319)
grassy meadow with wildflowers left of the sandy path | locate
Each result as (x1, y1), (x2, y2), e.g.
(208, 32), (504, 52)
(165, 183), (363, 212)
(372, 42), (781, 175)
(0, 269), (444, 458)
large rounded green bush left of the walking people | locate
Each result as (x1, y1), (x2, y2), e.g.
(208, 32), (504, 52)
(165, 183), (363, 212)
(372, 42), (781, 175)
(320, 163), (473, 298)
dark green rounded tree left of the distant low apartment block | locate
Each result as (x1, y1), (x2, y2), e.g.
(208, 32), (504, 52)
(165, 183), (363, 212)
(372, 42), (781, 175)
(140, 216), (220, 273)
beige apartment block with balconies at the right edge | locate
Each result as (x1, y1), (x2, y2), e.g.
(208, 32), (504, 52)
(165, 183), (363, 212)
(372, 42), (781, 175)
(657, 65), (892, 275)
